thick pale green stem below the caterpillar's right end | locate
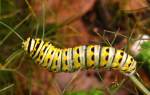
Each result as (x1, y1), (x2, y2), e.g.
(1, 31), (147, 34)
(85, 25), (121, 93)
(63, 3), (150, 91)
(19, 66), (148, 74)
(129, 75), (150, 95)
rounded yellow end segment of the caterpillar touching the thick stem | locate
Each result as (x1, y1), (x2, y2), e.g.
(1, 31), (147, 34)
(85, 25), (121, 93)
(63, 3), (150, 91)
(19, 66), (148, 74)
(121, 55), (136, 76)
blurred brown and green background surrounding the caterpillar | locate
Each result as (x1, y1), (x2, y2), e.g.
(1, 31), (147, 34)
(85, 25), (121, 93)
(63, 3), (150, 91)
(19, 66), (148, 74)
(0, 0), (150, 95)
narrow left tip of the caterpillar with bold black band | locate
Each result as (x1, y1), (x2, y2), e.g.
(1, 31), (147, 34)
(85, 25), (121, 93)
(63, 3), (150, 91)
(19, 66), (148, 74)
(22, 37), (35, 53)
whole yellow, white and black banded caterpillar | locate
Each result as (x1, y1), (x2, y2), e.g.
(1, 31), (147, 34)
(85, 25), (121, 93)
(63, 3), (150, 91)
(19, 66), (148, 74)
(23, 38), (136, 75)
